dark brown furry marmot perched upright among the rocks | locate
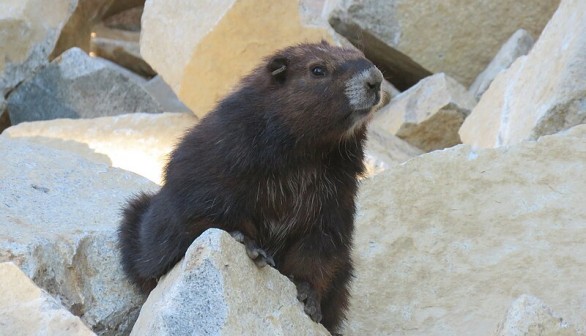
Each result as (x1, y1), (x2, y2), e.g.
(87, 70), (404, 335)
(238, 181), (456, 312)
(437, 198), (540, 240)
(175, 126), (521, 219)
(119, 42), (383, 332)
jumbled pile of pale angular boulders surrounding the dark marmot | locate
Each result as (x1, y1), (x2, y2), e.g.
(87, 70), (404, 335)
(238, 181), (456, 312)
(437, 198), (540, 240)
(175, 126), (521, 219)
(0, 0), (586, 336)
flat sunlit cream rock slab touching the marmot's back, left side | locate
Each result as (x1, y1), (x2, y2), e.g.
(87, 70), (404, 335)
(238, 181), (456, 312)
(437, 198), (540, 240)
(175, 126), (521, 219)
(2, 113), (197, 184)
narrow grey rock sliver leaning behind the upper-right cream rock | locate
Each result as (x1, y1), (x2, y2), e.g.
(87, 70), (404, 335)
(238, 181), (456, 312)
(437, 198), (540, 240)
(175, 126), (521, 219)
(468, 29), (535, 99)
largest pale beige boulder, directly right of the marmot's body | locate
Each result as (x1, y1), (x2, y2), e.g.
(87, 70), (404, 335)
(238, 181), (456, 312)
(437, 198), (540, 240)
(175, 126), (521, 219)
(344, 125), (586, 336)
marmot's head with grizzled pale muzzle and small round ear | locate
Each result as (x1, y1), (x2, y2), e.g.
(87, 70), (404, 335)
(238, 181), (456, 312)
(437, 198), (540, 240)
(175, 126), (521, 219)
(245, 42), (383, 143)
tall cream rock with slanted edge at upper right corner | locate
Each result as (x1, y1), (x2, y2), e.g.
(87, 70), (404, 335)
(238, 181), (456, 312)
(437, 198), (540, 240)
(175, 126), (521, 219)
(460, 0), (586, 147)
